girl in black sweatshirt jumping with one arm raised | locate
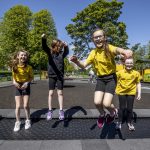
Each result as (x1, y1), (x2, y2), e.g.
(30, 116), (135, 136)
(42, 34), (69, 120)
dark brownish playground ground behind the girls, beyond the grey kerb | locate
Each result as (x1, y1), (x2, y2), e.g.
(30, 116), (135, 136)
(0, 80), (150, 109)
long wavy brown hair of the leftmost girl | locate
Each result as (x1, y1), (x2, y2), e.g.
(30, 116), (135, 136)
(9, 49), (29, 73)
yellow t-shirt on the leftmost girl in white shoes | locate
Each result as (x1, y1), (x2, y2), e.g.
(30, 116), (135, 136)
(12, 65), (33, 83)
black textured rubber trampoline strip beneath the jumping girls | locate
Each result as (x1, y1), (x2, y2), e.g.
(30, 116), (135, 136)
(0, 118), (150, 140)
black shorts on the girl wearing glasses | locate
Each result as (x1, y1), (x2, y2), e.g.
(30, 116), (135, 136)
(95, 74), (117, 94)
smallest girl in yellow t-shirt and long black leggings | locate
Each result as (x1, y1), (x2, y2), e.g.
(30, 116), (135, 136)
(116, 58), (141, 130)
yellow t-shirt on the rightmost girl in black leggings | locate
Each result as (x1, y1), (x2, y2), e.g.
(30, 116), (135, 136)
(116, 69), (141, 95)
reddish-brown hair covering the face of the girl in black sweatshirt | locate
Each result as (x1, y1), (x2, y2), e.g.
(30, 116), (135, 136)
(51, 39), (64, 53)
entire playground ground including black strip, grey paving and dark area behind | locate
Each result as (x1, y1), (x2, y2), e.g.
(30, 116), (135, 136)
(0, 79), (150, 150)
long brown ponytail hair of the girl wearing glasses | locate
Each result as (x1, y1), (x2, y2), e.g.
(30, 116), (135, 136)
(92, 28), (111, 58)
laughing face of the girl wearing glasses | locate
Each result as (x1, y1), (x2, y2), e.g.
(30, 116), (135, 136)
(92, 30), (106, 48)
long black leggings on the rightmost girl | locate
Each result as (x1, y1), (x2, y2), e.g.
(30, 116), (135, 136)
(118, 95), (135, 123)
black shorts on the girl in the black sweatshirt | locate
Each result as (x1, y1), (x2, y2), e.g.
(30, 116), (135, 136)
(49, 77), (64, 90)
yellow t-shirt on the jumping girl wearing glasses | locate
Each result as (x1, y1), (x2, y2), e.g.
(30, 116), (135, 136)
(86, 44), (117, 76)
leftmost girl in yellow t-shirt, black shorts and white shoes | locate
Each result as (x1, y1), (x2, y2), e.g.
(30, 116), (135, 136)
(11, 50), (33, 132)
